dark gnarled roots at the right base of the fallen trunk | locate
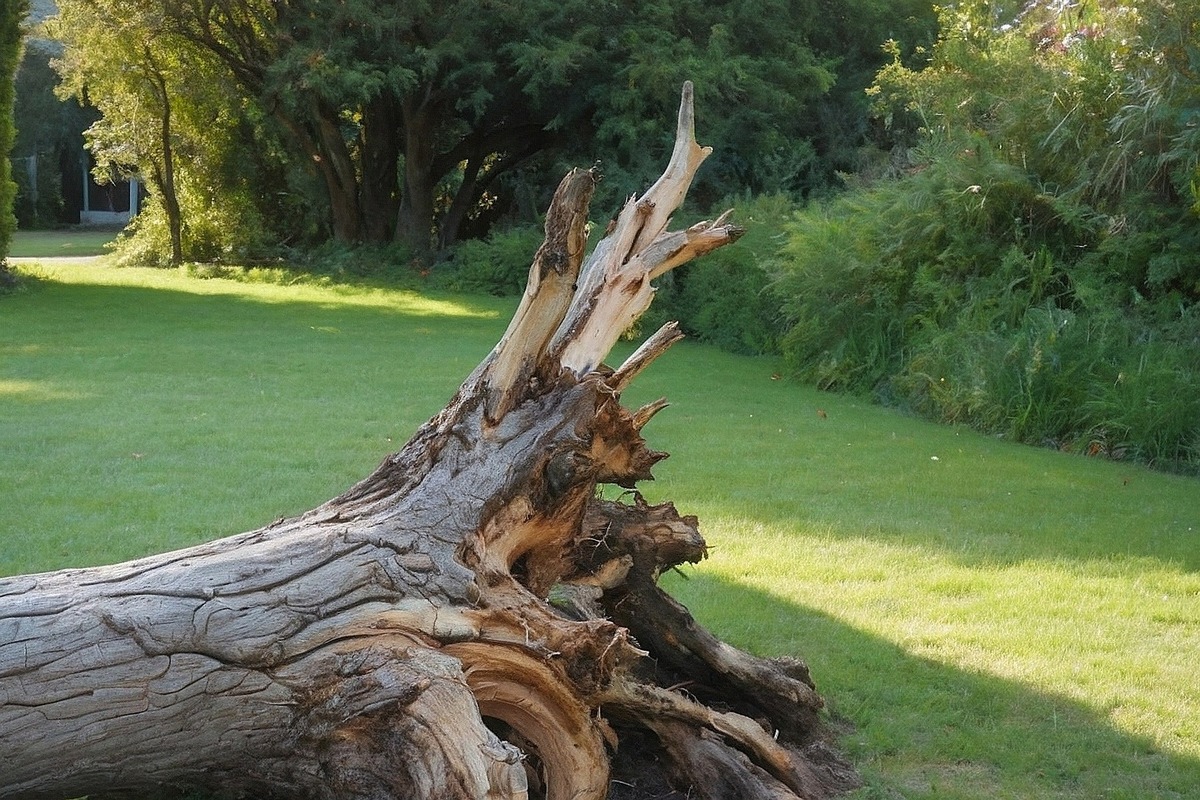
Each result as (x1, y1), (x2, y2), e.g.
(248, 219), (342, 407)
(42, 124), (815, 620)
(516, 493), (857, 800)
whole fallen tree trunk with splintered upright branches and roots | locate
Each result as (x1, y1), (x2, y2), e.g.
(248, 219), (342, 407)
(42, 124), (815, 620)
(0, 85), (854, 800)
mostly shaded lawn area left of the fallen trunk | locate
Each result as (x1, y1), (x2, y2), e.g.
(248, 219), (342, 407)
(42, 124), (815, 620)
(0, 264), (510, 573)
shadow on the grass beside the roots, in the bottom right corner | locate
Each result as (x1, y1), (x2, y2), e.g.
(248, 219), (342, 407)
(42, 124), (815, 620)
(671, 573), (1200, 800)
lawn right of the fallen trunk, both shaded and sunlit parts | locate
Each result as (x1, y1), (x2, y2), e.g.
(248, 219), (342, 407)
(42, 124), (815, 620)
(626, 345), (1200, 800)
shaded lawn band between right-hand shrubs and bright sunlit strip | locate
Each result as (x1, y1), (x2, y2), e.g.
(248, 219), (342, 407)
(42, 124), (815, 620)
(626, 343), (1200, 572)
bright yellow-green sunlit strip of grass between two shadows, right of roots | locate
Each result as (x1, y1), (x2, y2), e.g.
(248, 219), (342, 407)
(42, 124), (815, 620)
(672, 510), (1200, 758)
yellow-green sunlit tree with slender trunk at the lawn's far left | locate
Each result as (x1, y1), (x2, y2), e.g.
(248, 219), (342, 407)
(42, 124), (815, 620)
(47, 0), (287, 264)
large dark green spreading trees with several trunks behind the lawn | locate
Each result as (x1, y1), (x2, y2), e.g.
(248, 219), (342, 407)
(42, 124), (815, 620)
(49, 0), (929, 252)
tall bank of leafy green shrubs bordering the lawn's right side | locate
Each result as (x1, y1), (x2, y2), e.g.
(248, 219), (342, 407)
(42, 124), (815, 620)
(774, 2), (1200, 471)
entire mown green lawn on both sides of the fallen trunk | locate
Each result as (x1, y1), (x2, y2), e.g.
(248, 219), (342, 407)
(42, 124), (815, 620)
(0, 265), (1200, 800)
